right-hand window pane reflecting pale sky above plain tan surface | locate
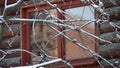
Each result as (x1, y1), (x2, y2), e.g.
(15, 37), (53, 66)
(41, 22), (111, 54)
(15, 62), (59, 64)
(65, 6), (95, 59)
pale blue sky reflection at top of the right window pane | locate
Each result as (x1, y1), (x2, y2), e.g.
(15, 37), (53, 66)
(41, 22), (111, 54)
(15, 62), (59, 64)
(65, 6), (94, 20)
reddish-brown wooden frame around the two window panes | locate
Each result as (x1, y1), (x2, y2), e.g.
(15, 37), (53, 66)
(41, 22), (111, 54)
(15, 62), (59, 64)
(20, 0), (98, 66)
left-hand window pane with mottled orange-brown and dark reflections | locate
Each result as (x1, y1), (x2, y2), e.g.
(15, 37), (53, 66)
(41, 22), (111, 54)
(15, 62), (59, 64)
(30, 9), (58, 64)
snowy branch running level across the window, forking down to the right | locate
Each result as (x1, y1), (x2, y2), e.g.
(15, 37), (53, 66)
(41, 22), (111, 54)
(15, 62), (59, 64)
(10, 18), (112, 44)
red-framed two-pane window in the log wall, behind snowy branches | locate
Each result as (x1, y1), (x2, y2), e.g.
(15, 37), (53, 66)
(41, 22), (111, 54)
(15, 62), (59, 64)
(21, 0), (96, 65)
